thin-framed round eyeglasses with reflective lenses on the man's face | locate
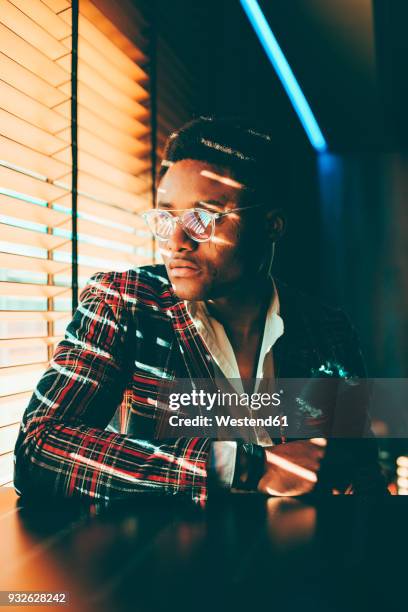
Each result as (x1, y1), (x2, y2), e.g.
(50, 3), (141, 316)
(141, 204), (263, 242)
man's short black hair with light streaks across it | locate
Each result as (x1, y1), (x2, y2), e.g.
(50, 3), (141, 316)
(159, 117), (287, 208)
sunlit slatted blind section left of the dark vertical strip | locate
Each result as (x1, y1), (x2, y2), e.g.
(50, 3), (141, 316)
(0, 0), (72, 485)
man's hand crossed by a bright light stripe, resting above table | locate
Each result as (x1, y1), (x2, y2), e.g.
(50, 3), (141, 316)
(258, 438), (327, 496)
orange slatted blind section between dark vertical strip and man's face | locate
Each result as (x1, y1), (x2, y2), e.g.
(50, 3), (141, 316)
(62, 0), (153, 286)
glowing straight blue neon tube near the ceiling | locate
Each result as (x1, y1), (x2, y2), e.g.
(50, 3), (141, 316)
(240, 0), (327, 151)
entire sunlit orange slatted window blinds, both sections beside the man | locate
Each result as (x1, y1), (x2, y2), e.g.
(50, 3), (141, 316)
(0, 0), (153, 486)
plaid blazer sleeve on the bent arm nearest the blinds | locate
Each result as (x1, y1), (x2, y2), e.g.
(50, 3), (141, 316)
(14, 273), (210, 502)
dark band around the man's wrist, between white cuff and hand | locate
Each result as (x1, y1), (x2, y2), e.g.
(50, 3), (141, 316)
(232, 442), (265, 491)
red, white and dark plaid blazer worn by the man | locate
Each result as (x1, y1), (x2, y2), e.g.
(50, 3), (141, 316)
(14, 265), (382, 502)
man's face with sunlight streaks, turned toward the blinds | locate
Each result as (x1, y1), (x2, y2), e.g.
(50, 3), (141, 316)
(157, 159), (265, 300)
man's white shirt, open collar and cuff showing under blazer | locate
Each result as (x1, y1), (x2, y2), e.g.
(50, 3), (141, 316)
(185, 278), (284, 488)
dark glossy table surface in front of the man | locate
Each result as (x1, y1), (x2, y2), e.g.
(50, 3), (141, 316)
(0, 489), (408, 612)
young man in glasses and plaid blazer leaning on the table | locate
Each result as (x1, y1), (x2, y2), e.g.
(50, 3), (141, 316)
(15, 118), (383, 501)
